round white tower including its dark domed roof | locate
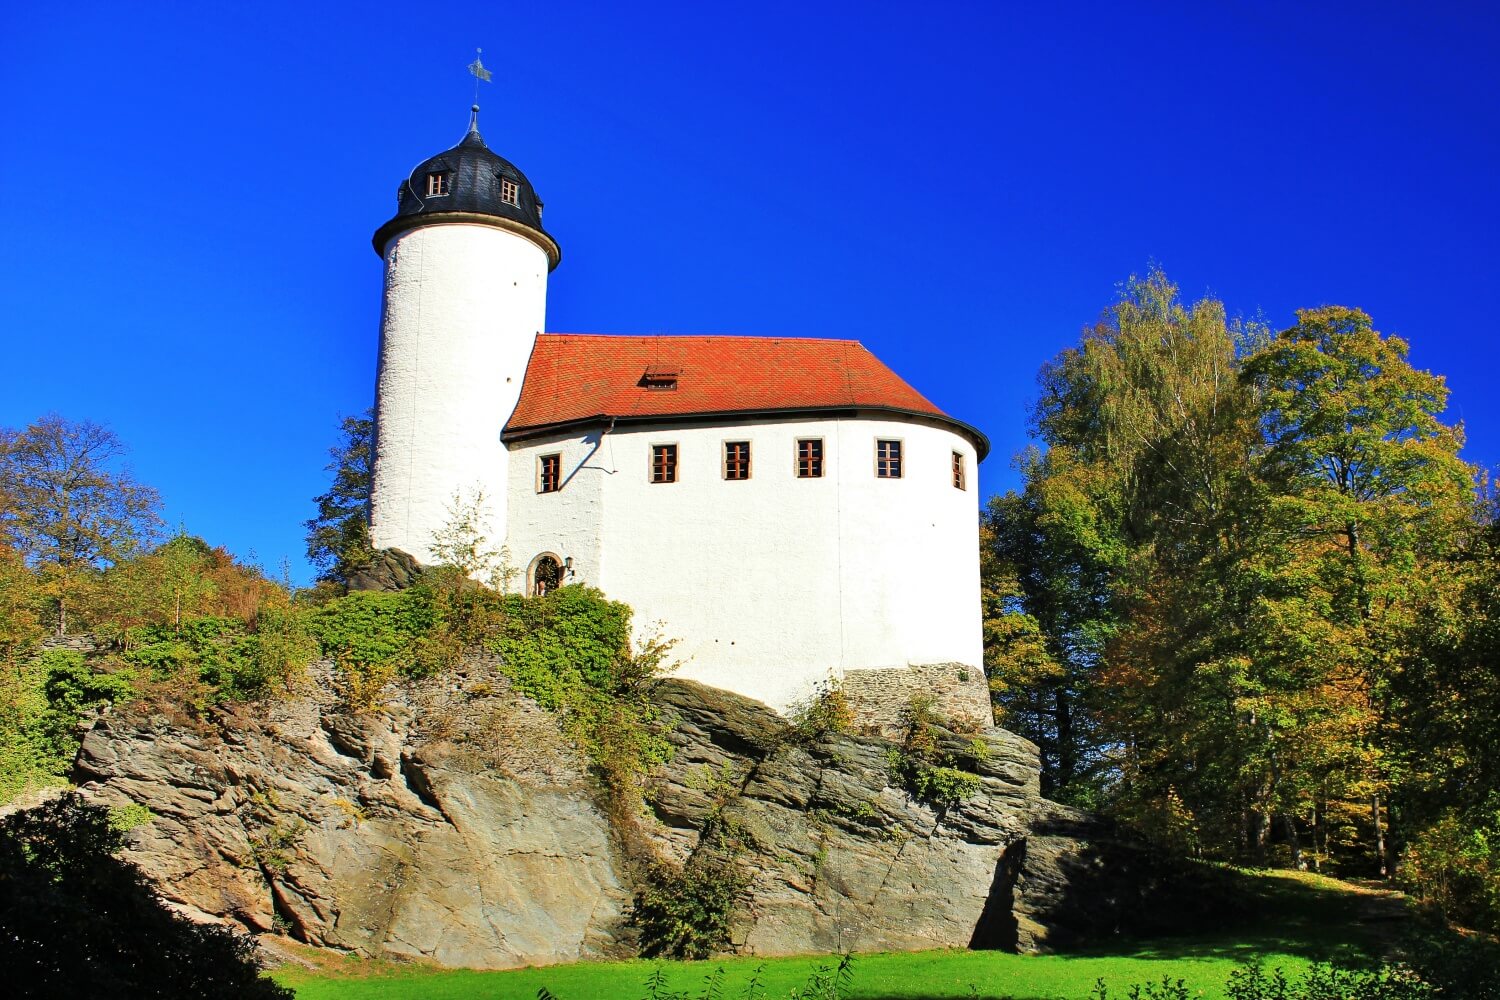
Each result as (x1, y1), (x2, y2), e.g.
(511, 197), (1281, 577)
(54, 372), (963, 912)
(371, 106), (561, 564)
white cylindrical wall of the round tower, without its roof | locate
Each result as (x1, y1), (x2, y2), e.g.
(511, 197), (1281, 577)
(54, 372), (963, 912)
(371, 223), (548, 562)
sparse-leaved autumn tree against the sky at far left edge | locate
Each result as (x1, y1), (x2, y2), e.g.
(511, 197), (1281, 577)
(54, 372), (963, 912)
(0, 414), (161, 636)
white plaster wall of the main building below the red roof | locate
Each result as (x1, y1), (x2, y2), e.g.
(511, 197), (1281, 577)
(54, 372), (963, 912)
(510, 418), (983, 709)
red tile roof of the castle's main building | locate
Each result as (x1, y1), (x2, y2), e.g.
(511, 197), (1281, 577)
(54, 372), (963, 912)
(506, 333), (987, 451)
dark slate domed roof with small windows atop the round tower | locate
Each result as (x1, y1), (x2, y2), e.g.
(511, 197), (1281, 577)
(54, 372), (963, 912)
(374, 105), (563, 267)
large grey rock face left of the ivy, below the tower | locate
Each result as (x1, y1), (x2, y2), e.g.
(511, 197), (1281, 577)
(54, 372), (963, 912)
(75, 672), (630, 969)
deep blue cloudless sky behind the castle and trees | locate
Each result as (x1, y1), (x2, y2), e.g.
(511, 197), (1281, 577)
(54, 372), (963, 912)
(0, 1), (1500, 580)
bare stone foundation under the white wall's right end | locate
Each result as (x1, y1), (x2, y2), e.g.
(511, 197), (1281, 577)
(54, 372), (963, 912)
(843, 663), (995, 738)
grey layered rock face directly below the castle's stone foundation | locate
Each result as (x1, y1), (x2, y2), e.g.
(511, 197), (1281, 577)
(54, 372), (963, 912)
(654, 682), (1038, 955)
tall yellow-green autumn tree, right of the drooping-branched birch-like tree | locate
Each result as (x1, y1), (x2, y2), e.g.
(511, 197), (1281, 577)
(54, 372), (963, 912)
(1244, 306), (1475, 874)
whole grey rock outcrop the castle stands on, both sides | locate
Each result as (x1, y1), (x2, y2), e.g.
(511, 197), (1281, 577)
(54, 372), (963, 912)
(75, 661), (1170, 969)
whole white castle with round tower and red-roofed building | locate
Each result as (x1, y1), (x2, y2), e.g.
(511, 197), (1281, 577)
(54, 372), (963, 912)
(371, 106), (990, 726)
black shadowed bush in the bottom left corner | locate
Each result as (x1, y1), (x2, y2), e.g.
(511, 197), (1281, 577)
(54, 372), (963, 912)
(0, 793), (293, 1000)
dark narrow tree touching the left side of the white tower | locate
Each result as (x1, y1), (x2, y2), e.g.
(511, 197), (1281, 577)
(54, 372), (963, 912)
(306, 411), (375, 583)
